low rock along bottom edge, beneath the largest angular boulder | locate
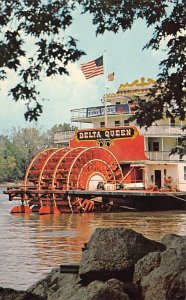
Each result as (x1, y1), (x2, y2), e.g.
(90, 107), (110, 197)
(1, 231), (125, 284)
(28, 271), (131, 300)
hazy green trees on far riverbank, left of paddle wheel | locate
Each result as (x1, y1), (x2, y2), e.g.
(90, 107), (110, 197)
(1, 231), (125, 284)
(0, 123), (74, 182)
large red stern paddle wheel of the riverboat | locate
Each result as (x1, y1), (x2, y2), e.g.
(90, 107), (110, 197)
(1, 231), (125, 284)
(11, 147), (123, 214)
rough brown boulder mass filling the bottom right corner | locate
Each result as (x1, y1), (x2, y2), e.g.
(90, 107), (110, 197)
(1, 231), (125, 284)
(134, 235), (186, 300)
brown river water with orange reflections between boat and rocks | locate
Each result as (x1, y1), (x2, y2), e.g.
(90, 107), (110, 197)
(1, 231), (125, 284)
(0, 187), (186, 290)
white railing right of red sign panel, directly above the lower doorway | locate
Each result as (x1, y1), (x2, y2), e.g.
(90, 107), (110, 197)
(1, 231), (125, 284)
(146, 151), (186, 161)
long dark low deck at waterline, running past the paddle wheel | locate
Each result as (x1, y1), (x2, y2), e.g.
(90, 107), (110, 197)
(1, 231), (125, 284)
(4, 186), (186, 211)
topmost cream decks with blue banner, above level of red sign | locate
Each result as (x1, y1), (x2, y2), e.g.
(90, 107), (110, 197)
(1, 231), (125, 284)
(71, 77), (186, 138)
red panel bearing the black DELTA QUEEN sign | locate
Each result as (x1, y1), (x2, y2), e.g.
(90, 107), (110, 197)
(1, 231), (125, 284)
(69, 126), (147, 162)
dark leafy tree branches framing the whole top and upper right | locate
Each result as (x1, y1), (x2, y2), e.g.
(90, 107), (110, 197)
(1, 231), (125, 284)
(0, 0), (186, 126)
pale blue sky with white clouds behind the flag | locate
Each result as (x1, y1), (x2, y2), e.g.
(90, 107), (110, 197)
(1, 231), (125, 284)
(0, 9), (166, 135)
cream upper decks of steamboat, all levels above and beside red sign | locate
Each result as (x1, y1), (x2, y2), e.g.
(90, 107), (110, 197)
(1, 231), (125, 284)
(55, 77), (186, 162)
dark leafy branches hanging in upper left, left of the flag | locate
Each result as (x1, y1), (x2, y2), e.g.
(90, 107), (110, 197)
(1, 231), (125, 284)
(0, 0), (84, 121)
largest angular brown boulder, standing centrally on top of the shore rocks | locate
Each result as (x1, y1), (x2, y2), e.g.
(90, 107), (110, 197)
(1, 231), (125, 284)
(79, 228), (166, 282)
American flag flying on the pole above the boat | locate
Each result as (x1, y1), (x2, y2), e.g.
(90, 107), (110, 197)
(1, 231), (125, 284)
(81, 55), (104, 79)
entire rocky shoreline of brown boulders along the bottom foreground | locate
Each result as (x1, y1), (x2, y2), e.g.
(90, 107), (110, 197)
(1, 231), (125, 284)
(0, 227), (186, 300)
